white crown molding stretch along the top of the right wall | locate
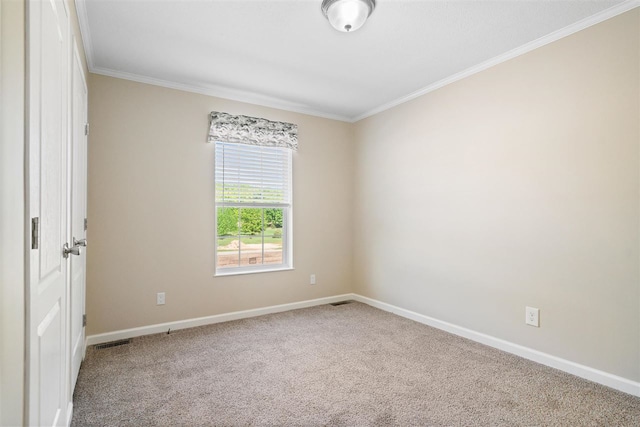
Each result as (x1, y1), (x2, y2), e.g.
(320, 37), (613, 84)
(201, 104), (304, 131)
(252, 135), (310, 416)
(350, 0), (640, 123)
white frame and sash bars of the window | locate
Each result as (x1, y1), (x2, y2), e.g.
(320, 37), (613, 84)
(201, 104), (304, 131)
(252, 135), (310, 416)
(213, 141), (294, 277)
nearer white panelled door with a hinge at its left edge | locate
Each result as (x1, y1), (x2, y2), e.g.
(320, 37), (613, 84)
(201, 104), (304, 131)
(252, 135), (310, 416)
(27, 0), (70, 426)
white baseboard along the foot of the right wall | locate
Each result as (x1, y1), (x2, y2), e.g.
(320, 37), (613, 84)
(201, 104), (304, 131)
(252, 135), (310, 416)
(351, 294), (640, 397)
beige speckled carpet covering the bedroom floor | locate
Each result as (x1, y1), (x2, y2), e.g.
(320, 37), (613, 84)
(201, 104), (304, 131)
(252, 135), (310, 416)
(72, 302), (640, 426)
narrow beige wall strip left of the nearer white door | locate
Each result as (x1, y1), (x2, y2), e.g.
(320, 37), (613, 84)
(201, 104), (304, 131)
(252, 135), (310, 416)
(0, 0), (25, 426)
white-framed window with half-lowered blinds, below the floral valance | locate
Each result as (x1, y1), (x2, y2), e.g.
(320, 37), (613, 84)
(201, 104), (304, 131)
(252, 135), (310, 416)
(215, 141), (292, 275)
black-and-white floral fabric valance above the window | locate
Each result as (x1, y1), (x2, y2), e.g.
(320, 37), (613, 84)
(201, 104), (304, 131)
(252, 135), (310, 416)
(209, 111), (298, 150)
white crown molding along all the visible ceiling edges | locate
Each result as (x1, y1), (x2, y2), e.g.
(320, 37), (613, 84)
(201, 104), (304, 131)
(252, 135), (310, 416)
(75, 0), (640, 123)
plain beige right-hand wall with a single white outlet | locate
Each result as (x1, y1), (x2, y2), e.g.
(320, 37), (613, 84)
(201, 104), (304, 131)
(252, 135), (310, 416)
(354, 9), (640, 381)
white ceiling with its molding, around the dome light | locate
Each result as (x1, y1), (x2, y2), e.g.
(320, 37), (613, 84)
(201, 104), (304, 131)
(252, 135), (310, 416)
(76, 0), (638, 121)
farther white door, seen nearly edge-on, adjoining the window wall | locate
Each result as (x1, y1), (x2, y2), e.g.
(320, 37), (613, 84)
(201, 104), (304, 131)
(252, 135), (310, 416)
(69, 45), (87, 396)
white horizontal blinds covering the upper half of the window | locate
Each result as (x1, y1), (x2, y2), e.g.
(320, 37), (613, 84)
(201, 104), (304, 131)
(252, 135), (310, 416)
(215, 141), (291, 207)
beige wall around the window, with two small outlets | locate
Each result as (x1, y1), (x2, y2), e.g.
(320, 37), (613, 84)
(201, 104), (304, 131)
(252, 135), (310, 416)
(87, 74), (353, 335)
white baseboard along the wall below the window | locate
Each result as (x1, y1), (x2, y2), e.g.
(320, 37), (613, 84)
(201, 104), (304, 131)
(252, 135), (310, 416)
(87, 294), (353, 346)
